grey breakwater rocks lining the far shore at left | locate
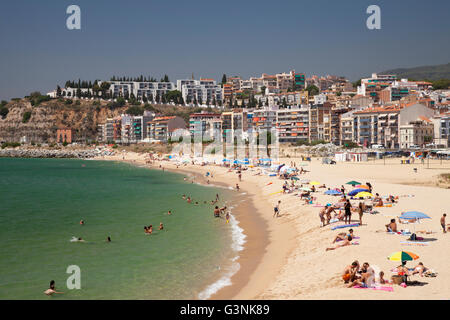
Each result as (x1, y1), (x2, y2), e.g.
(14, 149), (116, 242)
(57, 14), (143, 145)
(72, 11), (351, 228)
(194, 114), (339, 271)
(0, 148), (110, 159)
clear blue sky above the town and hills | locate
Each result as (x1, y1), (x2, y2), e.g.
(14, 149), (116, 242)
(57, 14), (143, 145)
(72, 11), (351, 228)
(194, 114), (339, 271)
(0, 0), (450, 99)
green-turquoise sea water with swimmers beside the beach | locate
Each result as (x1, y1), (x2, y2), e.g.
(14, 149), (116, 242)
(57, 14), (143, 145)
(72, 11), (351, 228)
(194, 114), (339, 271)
(0, 158), (232, 299)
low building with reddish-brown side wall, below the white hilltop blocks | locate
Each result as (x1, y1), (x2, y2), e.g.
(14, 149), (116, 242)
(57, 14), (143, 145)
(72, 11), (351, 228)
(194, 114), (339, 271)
(146, 116), (186, 142)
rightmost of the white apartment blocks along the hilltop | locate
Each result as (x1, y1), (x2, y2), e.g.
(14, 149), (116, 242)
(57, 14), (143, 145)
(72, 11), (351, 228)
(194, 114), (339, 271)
(177, 78), (222, 104)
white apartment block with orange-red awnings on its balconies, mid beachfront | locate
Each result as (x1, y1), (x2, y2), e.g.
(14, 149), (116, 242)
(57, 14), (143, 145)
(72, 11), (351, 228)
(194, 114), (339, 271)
(276, 106), (309, 143)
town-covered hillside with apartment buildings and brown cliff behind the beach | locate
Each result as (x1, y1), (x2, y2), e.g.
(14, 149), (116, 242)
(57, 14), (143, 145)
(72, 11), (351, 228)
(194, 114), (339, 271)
(0, 71), (450, 149)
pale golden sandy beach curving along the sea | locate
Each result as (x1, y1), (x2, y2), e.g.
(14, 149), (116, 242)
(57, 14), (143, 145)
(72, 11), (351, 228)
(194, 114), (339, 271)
(98, 153), (450, 300)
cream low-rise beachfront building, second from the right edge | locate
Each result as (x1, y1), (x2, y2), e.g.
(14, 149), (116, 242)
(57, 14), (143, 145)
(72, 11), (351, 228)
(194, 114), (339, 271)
(399, 117), (434, 149)
